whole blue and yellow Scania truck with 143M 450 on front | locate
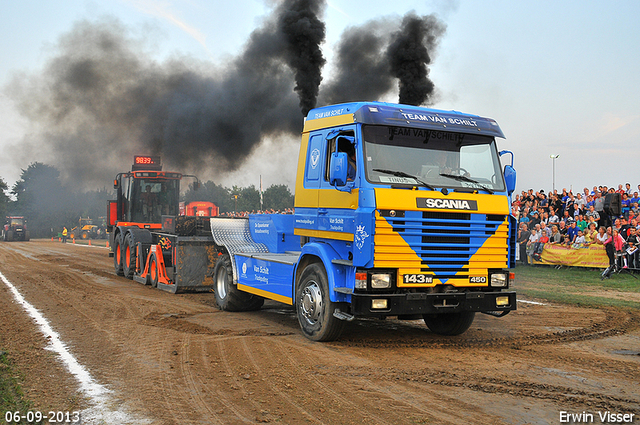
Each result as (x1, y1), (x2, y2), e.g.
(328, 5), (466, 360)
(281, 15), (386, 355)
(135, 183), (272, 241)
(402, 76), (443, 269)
(210, 102), (516, 341)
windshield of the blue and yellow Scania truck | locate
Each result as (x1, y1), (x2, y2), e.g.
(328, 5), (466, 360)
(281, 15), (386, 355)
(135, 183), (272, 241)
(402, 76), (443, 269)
(362, 125), (505, 192)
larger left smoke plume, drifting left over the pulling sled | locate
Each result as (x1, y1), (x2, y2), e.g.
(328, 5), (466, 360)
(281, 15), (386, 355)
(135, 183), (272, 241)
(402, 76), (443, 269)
(6, 1), (324, 187)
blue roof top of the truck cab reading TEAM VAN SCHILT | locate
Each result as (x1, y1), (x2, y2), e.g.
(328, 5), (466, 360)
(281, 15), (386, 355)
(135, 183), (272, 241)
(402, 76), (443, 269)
(307, 102), (504, 138)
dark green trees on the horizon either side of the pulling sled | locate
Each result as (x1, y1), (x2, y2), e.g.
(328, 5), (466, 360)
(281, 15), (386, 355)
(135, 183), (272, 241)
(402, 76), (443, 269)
(0, 162), (293, 238)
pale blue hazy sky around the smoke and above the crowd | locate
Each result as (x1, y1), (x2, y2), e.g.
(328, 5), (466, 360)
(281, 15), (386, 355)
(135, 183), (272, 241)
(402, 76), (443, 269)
(0, 0), (640, 194)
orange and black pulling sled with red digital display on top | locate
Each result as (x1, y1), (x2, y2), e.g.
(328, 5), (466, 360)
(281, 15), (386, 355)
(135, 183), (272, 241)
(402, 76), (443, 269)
(107, 156), (215, 292)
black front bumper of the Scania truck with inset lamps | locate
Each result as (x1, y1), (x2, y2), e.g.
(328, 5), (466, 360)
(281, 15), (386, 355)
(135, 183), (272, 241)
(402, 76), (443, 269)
(351, 292), (516, 317)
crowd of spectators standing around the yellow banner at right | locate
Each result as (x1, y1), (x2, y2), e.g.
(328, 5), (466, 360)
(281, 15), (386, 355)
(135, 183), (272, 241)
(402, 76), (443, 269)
(511, 183), (640, 269)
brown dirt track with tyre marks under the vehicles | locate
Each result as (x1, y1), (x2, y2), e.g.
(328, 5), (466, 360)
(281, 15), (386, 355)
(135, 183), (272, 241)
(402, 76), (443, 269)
(0, 240), (640, 425)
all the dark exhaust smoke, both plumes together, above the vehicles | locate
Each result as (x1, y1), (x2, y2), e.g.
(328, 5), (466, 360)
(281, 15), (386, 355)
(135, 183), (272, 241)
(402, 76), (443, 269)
(5, 0), (444, 189)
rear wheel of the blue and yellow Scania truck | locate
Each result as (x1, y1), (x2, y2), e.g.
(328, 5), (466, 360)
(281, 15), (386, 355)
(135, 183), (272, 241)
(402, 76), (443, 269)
(213, 254), (264, 311)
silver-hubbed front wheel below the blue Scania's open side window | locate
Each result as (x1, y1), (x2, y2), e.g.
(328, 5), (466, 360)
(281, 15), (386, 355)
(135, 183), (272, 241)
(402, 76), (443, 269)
(296, 263), (344, 341)
